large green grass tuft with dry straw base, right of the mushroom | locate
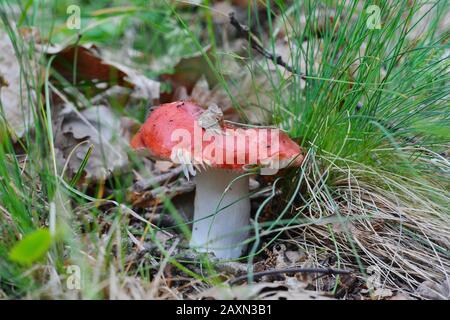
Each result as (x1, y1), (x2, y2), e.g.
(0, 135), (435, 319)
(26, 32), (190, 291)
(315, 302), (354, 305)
(246, 1), (449, 291)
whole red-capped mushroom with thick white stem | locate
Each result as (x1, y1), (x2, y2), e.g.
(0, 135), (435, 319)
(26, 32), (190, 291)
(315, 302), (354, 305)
(131, 101), (303, 259)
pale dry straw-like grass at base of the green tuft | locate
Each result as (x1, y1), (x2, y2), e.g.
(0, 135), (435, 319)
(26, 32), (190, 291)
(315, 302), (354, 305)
(276, 148), (450, 294)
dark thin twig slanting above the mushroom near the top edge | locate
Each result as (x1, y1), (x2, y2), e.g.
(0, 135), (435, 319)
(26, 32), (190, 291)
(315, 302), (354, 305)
(229, 12), (306, 79)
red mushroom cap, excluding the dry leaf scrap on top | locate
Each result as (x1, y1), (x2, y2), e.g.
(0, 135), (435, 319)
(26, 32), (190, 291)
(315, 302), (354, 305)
(131, 101), (303, 170)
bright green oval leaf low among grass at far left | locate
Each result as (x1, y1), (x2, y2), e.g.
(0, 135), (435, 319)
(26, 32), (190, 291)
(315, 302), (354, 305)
(9, 229), (52, 265)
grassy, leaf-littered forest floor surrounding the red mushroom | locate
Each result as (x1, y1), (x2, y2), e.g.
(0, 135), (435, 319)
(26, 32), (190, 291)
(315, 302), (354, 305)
(0, 0), (450, 300)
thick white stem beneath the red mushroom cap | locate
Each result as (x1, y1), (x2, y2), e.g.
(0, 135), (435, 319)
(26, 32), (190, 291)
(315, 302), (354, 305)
(190, 169), (250, 259)
